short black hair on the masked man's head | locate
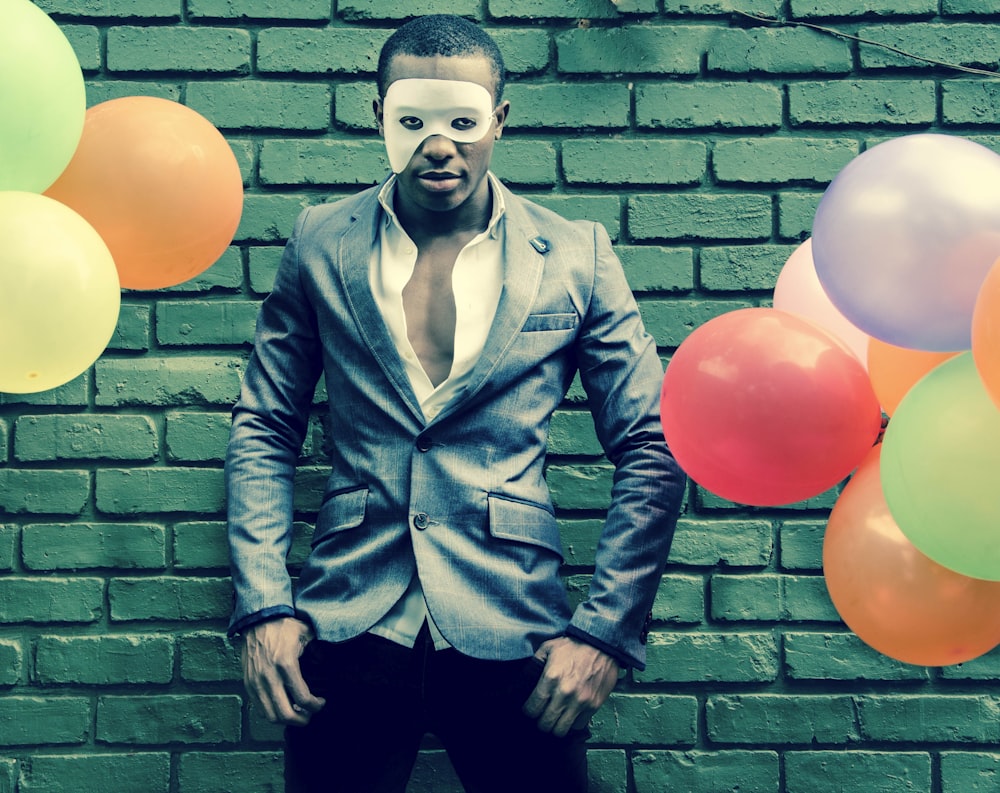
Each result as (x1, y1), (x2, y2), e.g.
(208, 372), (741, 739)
(378, 14), (506, 104)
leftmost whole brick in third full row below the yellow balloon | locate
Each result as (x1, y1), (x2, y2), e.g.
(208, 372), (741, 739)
(21, 523), (167, 570)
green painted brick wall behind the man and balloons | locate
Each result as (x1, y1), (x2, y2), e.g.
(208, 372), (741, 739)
(0, 0), (1000, 793)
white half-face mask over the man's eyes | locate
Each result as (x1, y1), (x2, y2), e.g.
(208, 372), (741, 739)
(382, 77), (493, 173)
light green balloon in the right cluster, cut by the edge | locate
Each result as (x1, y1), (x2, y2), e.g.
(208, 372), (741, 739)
(881, 352), (1000, 581)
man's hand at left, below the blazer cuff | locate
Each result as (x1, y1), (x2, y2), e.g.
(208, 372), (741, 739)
(240, 617), (326, 726)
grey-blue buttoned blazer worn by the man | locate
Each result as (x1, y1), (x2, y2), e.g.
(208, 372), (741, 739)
(226, 179), (685, 668)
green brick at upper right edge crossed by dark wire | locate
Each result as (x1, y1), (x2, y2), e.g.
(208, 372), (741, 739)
(857, 22), (1000, 69)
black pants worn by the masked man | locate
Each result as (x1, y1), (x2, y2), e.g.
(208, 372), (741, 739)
(285, 634), (589, 793)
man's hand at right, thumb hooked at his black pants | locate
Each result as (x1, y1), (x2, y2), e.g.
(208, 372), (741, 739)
(524, 636), (620, 737)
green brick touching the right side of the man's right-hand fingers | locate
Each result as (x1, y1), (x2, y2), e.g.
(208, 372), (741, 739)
(591, 694), (698, 746)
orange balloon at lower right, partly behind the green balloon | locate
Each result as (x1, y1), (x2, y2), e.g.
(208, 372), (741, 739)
(823, 447), (1000, 666)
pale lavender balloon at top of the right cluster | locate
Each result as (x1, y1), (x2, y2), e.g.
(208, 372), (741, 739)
(812, 134), (1000, 352)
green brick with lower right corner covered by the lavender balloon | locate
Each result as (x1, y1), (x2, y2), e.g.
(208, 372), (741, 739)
(712, 138), (861, 184)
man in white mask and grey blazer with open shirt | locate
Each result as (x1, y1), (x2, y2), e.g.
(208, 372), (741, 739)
(226, 15), (684, 793)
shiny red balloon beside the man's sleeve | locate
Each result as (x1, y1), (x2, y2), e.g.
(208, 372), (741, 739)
(660, 308), (882, 506)
